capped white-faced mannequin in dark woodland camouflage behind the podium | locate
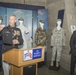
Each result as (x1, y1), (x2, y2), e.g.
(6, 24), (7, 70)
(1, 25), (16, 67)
(35, 20), (46, 66)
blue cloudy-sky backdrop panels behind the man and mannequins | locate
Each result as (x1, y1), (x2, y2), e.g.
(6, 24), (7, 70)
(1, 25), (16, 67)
(0, 7), (48, 46)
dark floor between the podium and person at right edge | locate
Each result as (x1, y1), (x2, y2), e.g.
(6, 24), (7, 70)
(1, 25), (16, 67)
(38, 67), (69, 75)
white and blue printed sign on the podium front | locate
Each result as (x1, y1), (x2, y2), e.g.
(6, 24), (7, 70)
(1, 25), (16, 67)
(23, 48), (42, 61)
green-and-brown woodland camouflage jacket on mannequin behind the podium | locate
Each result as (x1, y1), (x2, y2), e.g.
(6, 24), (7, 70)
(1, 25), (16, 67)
(35, 28), (46, 46)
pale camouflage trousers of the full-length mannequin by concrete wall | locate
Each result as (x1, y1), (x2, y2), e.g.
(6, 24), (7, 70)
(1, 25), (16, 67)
(51, 46), (62, 61)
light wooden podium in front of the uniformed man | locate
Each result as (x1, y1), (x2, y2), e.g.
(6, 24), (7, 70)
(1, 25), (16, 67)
(2, 46), (44, 75)
